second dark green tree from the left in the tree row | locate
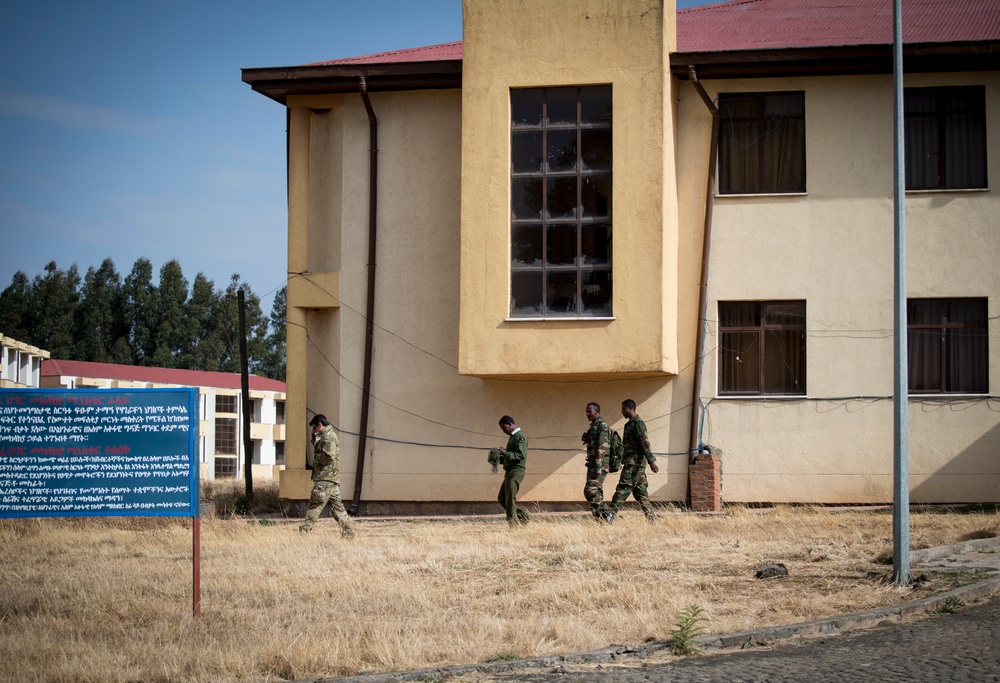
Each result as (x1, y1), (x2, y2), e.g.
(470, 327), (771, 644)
(27, 261), (80, 359)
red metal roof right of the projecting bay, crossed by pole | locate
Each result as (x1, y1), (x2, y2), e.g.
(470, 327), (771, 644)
(677, 0), (1000, 52)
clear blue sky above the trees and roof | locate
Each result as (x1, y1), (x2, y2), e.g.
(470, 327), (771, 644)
(0, 0), (711, 314)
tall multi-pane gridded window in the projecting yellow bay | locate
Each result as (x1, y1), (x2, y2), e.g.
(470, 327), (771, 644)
(510, 85), (612, 318)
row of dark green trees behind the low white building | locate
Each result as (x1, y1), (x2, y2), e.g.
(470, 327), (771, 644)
(0, 258), (286, 380)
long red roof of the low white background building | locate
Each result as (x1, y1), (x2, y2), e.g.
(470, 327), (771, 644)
(42, 358), (285, 392)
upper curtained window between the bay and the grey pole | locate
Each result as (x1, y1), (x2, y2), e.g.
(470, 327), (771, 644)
(719, 92), (806, 194)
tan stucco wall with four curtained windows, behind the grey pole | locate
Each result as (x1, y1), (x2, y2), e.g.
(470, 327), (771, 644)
(678, 73), (1000, 503)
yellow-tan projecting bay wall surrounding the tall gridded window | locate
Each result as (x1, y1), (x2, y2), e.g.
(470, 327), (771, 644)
(459, 0), (678, 376)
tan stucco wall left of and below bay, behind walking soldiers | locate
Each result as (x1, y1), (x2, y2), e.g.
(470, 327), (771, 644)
(280, 83), (700, 509)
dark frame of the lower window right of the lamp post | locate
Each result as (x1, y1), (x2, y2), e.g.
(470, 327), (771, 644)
(906, 297), (990, 395)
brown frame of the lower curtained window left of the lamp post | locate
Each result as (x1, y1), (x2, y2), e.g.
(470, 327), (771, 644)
(716, 299), (808, 397)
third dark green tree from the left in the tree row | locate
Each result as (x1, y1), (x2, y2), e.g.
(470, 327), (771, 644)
(73, 258), (123, 363)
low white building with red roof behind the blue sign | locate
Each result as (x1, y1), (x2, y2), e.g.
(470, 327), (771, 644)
(40, 358), (286, 479)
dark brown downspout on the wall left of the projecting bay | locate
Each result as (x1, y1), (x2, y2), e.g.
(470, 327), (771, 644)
(348, 76), (378, 515)
